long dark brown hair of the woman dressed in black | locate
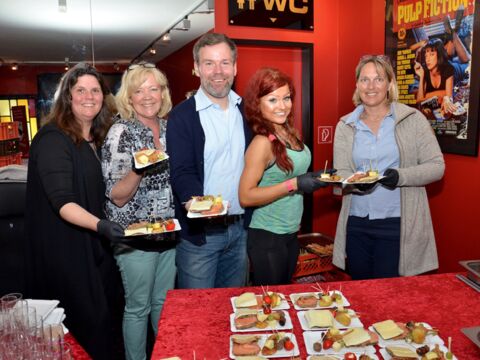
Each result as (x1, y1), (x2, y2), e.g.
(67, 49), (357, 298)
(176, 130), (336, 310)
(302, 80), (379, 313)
(47, 63), (113, 147)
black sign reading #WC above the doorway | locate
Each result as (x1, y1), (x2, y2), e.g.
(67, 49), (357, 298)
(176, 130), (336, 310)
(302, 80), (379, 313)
(228, 0), (314, 30)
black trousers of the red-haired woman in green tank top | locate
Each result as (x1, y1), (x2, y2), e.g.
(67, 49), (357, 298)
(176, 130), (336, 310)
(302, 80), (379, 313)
(247, 229), (299, 285)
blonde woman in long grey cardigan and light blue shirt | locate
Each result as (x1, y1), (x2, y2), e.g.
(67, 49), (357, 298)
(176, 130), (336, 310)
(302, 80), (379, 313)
(333, 55), (445, 279)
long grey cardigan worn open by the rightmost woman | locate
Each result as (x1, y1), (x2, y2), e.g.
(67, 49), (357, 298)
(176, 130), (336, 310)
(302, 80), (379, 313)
(333, 103), (445, 276)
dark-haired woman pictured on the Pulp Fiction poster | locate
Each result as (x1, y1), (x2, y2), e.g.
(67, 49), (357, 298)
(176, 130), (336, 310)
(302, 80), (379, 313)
(415, 38), (456, 113)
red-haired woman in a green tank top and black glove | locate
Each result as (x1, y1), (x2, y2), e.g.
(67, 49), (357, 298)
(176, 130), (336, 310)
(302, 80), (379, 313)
(239, 68), (326, 285)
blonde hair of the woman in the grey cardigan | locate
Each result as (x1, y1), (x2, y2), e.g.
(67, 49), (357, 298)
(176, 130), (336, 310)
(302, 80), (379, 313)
(352, 55), (398, 106)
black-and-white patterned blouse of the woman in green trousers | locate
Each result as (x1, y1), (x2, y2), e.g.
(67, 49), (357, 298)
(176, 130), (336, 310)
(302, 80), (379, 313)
(102, 119), (175, 234)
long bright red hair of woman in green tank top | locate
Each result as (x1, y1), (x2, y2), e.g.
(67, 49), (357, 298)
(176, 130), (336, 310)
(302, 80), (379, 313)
(244, 68), (303, 172)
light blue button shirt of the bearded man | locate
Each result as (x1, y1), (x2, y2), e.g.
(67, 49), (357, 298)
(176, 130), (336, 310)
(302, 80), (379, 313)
(195, 88), (245, 214)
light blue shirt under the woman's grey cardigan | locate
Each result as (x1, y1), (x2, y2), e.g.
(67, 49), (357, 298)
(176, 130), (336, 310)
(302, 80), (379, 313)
(347, 105), (400, 220)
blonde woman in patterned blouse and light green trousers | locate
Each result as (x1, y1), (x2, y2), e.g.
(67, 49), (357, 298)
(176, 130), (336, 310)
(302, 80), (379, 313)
(102, 62), (176, 360)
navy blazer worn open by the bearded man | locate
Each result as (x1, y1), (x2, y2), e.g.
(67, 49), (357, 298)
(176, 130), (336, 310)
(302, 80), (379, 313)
(167, 96), (252, 245)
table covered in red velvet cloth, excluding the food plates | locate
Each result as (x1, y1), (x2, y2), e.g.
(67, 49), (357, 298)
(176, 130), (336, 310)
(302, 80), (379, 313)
(152, 274), (480, 360)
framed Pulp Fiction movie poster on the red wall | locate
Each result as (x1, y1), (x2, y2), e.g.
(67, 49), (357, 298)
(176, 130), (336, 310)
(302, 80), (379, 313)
(385, 0), (480, 156)
